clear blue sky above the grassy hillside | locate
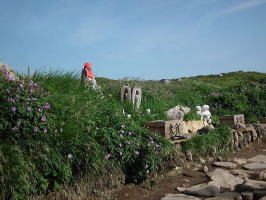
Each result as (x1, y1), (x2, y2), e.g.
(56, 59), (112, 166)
(0, 0), (266, 79)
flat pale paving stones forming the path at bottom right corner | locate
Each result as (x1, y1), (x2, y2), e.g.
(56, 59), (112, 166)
(161, 155), (266, 200)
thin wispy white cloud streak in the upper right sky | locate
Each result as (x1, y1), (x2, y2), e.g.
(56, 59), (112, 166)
(222, 0), (266, 14)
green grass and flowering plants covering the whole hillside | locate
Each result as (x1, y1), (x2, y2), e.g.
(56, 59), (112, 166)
(0, 69), (266, 199)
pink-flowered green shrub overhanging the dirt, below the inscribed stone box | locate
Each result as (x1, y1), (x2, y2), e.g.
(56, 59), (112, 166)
(97, 125), (174, 182)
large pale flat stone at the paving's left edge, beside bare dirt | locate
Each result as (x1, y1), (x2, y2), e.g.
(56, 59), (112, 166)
(207, 168), (244, 191)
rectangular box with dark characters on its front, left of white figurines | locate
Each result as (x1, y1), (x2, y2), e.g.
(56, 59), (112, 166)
(145, 120), (185, 139)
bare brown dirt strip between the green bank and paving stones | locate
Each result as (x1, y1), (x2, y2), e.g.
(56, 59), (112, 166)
(111, 143), (266, 200)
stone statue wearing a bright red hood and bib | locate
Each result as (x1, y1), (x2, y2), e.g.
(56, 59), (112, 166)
(81, 62), (99, 90)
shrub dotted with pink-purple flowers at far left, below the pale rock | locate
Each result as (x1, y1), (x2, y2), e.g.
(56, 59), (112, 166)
(0, 76), (56, 141)
